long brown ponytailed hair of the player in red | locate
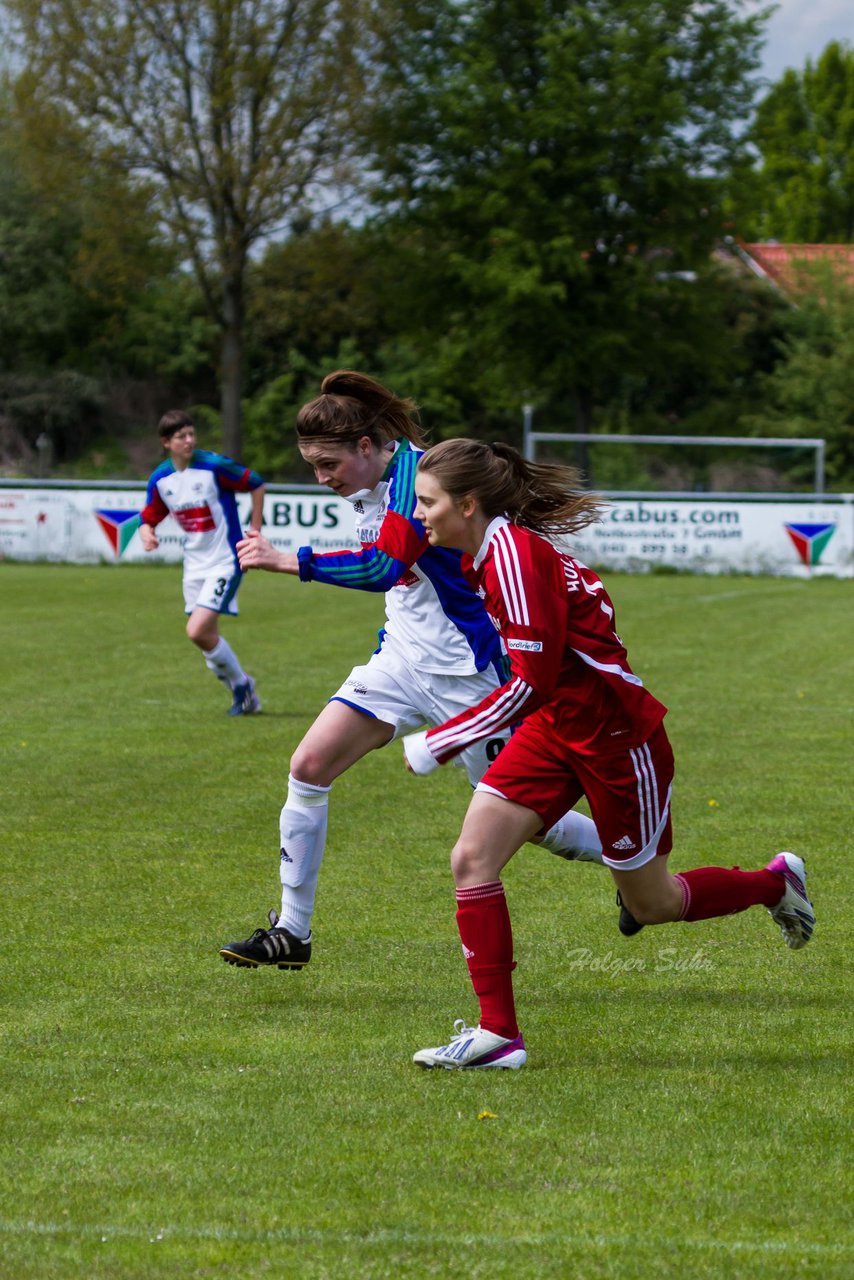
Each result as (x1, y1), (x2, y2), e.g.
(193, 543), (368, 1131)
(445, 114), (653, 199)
(419, 439), (604, 536)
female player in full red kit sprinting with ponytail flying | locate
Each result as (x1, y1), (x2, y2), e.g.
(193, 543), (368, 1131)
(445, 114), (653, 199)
(403, 440), (816, 1068)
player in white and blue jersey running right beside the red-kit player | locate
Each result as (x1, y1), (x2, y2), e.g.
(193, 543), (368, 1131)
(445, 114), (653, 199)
(220, 370), (602, 969)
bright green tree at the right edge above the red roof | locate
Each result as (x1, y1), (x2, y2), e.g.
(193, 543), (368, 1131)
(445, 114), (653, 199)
(741, 41), (854, 244)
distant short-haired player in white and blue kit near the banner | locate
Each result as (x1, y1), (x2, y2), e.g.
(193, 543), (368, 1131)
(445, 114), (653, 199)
(140, 408), (264, 716)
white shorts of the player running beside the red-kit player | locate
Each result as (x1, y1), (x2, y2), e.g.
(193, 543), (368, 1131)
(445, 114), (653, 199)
(329, 645), (510, 787)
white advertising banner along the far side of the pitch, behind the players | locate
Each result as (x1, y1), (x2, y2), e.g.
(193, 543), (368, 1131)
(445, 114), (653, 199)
(0, 481), (854, 577)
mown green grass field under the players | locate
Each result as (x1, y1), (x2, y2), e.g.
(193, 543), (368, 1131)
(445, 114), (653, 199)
(0, 563), (854, 1280)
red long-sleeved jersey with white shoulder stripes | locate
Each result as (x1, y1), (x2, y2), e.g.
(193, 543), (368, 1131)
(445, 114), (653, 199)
(426, 516), (667, 764)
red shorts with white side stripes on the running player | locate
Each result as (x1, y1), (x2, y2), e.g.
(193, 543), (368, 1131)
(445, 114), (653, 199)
(476, 721), (673, 870)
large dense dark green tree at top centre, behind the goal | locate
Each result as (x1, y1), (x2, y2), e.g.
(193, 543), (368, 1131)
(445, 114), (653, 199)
(363, 0), (767, 428)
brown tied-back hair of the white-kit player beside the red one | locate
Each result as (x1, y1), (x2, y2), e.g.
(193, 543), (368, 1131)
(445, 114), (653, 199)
(297, 369), (426, 448)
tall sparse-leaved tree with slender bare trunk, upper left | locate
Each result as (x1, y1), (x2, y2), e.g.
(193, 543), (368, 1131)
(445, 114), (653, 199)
(8, 0), (368, 454)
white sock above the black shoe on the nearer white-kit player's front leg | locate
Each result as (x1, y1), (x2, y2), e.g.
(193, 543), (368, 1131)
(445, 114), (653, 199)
(278, 774), (332, 938)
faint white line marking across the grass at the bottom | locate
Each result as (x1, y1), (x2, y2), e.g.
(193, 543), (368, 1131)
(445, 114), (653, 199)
(0, 1220), (854, 1258)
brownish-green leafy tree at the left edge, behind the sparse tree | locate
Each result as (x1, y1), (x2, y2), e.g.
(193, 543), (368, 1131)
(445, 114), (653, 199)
(0, 81), (214, 466)
